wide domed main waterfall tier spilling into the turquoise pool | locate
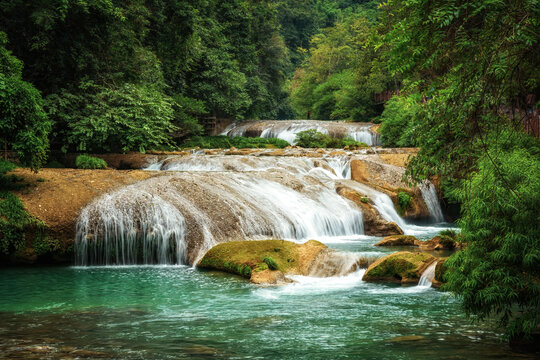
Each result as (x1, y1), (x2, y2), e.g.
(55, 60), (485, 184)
(76, 170), (364, 265)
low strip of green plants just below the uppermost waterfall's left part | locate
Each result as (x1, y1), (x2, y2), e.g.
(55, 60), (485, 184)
(180, 135), (290, 149)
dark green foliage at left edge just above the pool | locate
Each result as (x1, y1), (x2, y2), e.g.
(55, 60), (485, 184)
(0, 191), (46, 255)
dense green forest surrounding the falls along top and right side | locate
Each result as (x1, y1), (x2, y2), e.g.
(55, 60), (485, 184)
(0, 0), (540, 344)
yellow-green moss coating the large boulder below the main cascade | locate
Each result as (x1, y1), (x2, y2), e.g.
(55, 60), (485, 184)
(198, 240), (326, 278)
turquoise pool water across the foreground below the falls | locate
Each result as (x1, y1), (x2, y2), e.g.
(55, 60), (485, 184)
(0, 231), (524, 359)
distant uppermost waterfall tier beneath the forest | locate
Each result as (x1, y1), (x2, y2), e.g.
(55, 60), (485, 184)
(222, 120), (380, 146)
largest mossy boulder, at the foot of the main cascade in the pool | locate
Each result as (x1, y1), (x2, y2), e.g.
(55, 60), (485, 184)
(197, 240), (326, 284)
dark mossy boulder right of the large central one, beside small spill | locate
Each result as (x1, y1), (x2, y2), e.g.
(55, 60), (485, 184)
(362, 251), (436, 284)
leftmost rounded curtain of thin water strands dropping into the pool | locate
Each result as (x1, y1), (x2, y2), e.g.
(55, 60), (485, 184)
(75, 186), (186, 265)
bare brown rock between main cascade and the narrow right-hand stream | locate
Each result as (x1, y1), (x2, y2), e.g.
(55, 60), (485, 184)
(336, 185), (403, 236)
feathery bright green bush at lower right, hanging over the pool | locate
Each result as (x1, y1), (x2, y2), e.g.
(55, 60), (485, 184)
(445, 141), (540, 338)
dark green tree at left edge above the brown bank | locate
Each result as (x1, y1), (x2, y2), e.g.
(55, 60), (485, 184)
(0, 32), (51, 171)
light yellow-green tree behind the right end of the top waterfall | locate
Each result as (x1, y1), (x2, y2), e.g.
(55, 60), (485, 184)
(290, 13), (391, 121)
